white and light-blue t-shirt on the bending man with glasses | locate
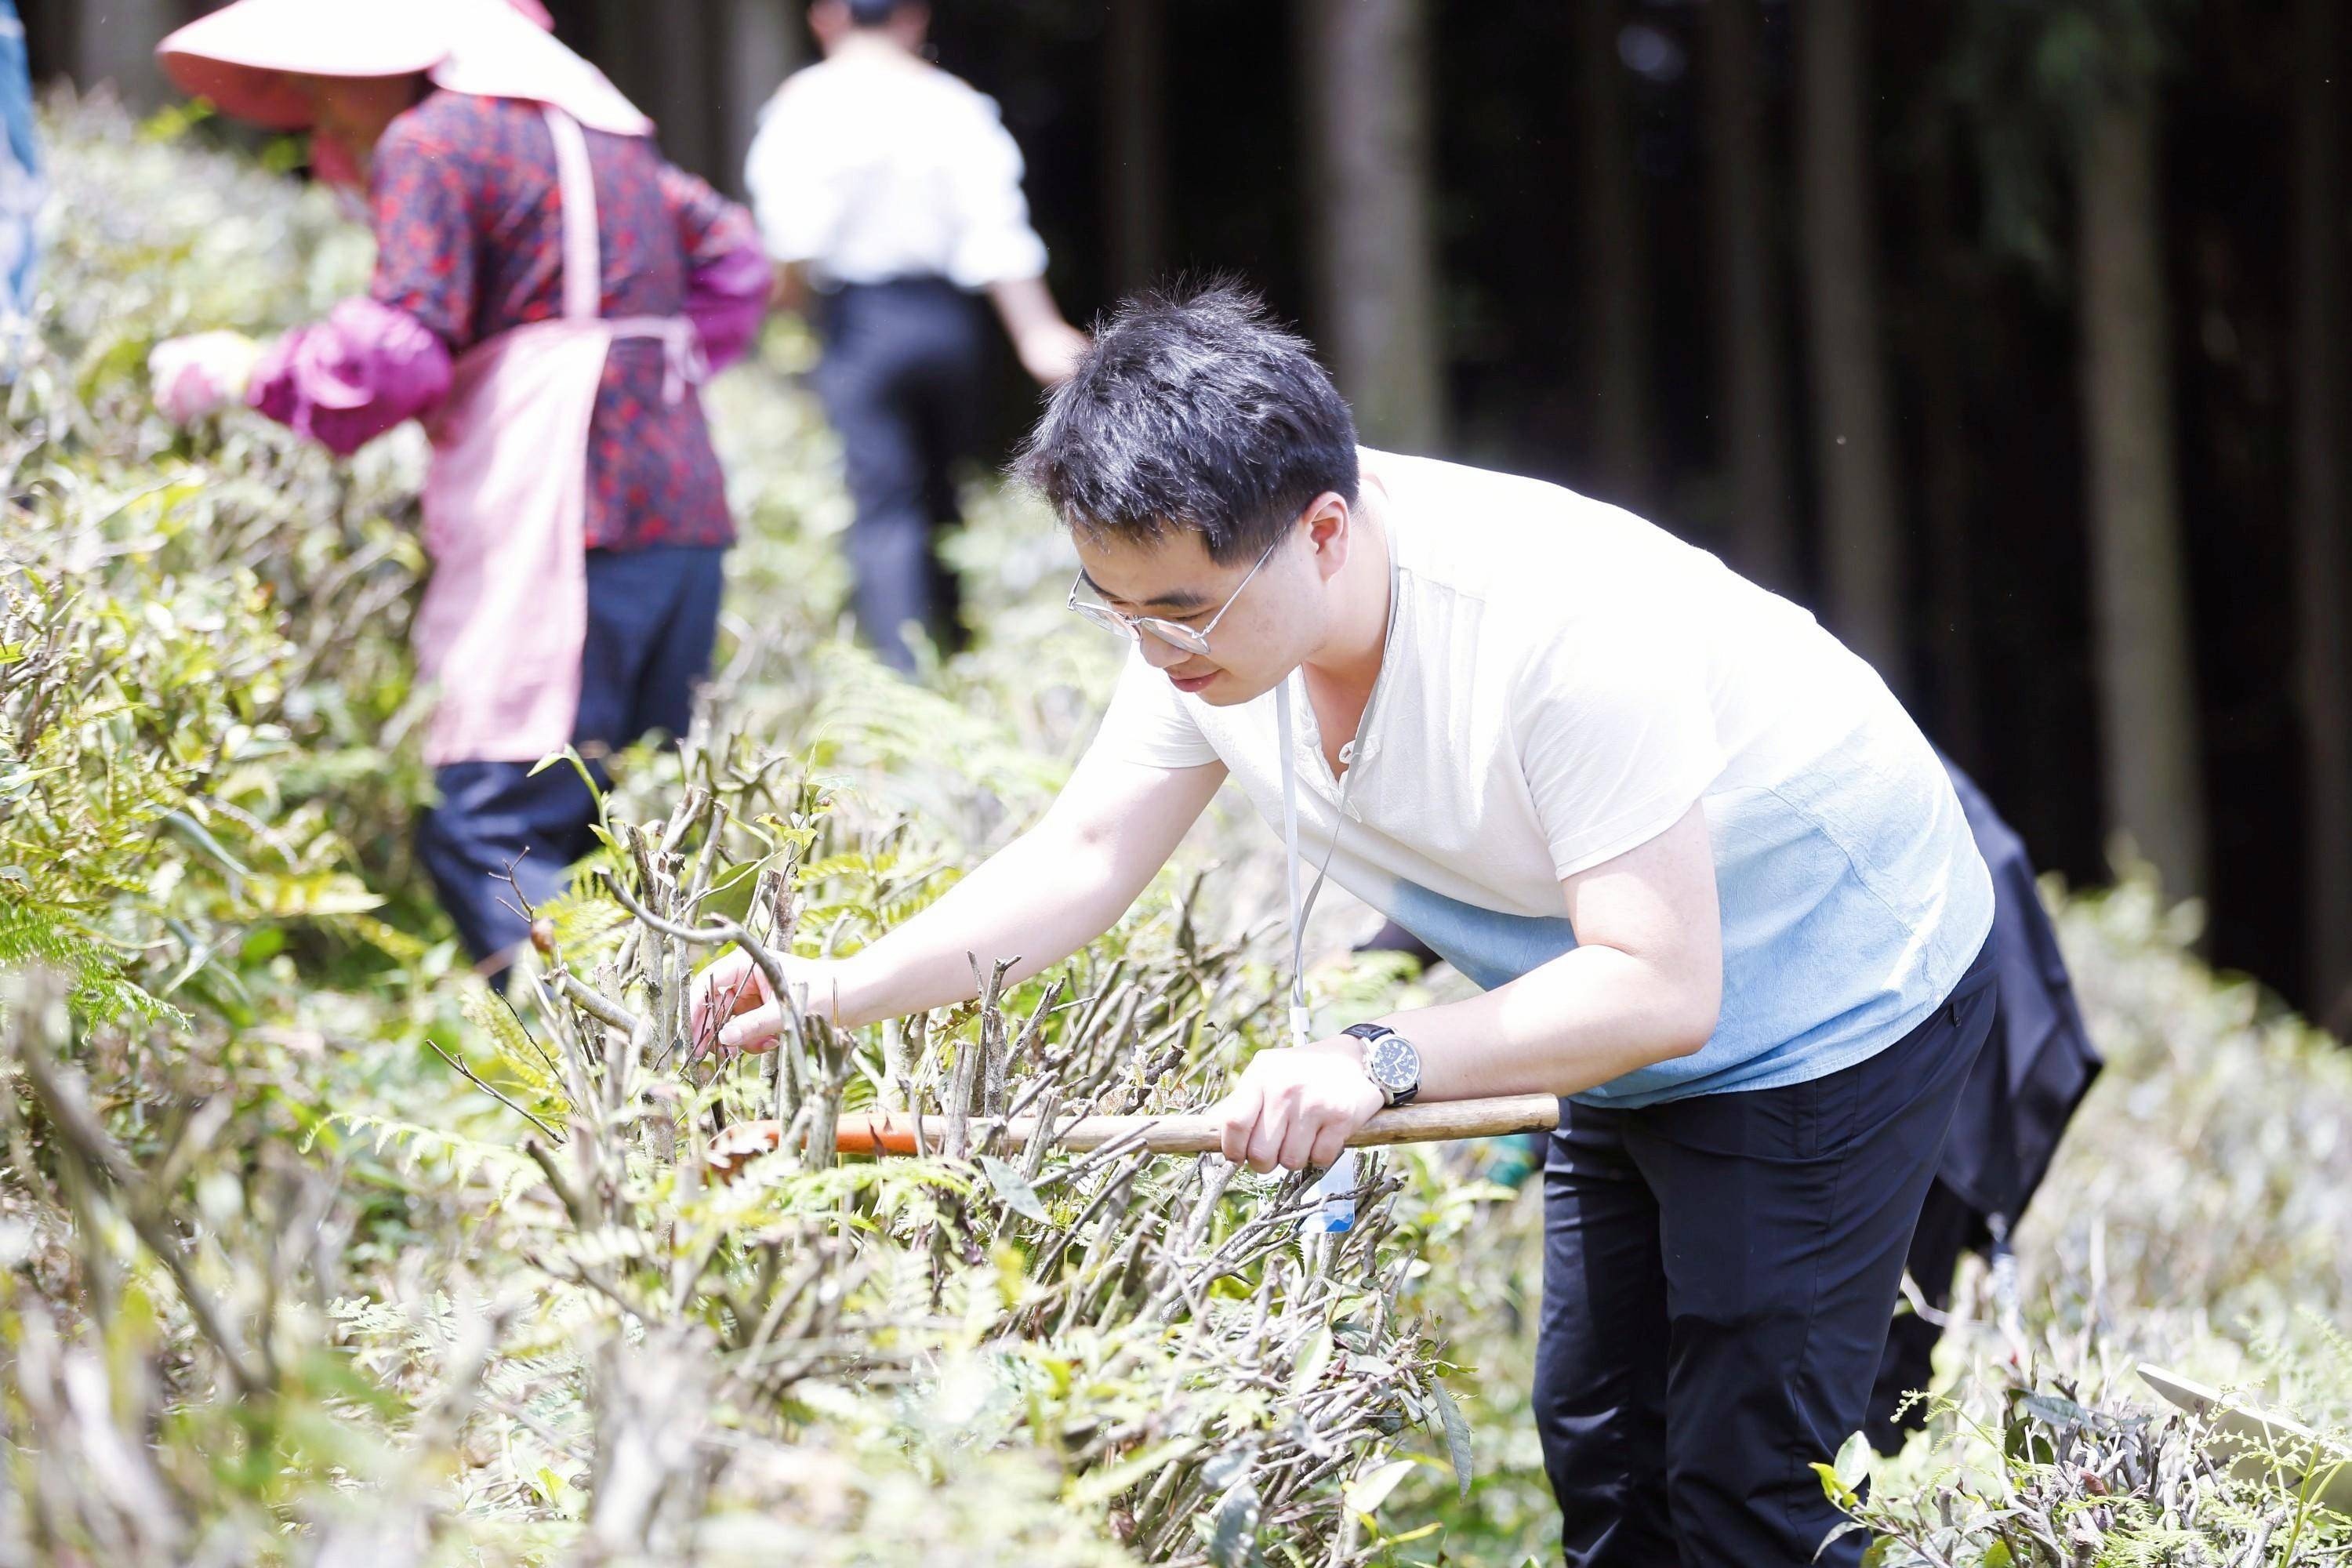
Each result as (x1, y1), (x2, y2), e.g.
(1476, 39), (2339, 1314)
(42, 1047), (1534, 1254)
(1094, 452), (1992, 1107)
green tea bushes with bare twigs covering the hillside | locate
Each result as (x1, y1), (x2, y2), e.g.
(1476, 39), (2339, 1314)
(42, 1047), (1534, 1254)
(0, 103), (2352, 1568)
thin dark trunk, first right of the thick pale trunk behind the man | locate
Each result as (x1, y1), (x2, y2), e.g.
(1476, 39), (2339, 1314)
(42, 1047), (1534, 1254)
(1571, 0), (1658, 510)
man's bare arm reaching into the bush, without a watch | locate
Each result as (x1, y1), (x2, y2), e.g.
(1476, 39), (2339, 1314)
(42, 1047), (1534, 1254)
(694, 750), (1225, 1048)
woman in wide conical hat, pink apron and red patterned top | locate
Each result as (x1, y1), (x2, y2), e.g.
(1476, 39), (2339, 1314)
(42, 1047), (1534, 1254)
(153, 0), (767, 973)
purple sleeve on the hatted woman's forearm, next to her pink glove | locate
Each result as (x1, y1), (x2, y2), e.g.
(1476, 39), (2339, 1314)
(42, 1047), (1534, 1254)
(245, 299), (449, 456)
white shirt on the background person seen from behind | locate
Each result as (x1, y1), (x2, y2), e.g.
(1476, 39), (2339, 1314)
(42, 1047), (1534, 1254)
(743, 49), (1044, 289)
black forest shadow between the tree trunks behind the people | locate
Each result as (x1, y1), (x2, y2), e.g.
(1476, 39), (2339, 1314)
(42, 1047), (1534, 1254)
(26, 0), (2352, 1013)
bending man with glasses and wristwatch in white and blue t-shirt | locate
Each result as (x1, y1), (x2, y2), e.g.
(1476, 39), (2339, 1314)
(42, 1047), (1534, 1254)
(696, 292), (1992, 1568)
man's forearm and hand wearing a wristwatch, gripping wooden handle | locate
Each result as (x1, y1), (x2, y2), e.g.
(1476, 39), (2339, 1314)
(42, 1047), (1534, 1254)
(1209, 804), (1724, 1171)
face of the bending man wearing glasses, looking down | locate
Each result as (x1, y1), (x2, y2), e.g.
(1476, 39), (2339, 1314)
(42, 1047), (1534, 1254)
(1077, 527), (1324, 708)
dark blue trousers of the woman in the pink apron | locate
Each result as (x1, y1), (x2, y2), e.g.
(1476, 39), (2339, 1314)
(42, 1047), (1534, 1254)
(416, 546), (727, 961)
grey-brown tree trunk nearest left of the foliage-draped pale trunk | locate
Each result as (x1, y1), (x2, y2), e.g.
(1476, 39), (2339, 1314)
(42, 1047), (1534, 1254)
(1795, 0), (1905, 691)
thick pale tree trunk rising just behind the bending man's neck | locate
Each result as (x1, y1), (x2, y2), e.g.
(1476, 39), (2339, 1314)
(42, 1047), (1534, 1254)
(1301, 0), (1444, 452)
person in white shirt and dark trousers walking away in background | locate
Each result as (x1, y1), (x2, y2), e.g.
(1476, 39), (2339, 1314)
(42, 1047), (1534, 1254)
(746, 0), (1087, 670)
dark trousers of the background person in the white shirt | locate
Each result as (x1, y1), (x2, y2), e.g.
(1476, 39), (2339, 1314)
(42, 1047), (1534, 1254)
(816, 278), (988, 670)
